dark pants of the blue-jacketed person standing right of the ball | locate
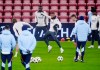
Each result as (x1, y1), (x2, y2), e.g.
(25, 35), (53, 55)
(76, 41), (86, 60)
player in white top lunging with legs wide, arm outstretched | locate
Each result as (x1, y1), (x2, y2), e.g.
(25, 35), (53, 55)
(42, 12), (64, 53)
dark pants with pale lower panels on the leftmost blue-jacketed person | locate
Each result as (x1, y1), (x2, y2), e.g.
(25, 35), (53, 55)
(1, 53), (13, 70)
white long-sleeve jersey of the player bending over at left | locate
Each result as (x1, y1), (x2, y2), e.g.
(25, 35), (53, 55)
(13, 21), (33, 37)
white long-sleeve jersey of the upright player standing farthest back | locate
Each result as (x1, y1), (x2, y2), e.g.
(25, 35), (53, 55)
(35, 11), (48, 27)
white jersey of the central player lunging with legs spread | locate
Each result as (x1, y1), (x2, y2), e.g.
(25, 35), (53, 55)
(49, 18), (62, 32)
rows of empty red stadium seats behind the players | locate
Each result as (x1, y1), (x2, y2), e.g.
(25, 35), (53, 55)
(0, 0), (100, 23)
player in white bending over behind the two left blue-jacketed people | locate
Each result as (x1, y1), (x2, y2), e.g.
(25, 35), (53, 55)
(12, 19), (33, 57)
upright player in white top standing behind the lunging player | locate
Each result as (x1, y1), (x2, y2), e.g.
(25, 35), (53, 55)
(35, 6), (48, 37)
